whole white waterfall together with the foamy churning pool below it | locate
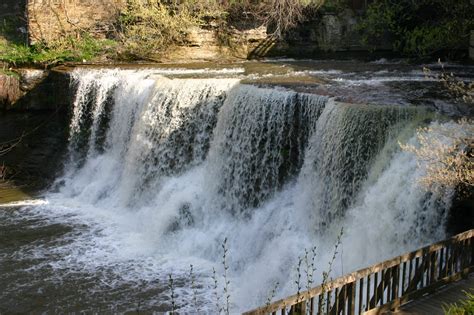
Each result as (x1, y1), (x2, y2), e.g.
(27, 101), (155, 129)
(0, 63), (470, 313)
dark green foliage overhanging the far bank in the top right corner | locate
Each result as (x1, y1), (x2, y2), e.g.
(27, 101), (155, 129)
(360, 0), (474, 57)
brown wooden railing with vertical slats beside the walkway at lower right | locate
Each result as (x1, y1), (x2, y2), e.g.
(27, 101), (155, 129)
(244, 229), (474, 315)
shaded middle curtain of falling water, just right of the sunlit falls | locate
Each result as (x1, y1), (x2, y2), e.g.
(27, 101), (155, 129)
(209, 85), (327, 209)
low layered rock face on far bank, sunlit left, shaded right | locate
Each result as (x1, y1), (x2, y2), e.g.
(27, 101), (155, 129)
(166, 9), (391, 60)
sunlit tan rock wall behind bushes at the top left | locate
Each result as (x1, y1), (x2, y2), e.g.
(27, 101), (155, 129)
(27, 0), (123, 43)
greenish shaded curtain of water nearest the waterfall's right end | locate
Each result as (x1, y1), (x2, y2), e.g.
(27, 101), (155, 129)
(301, 102), (430, 225)
